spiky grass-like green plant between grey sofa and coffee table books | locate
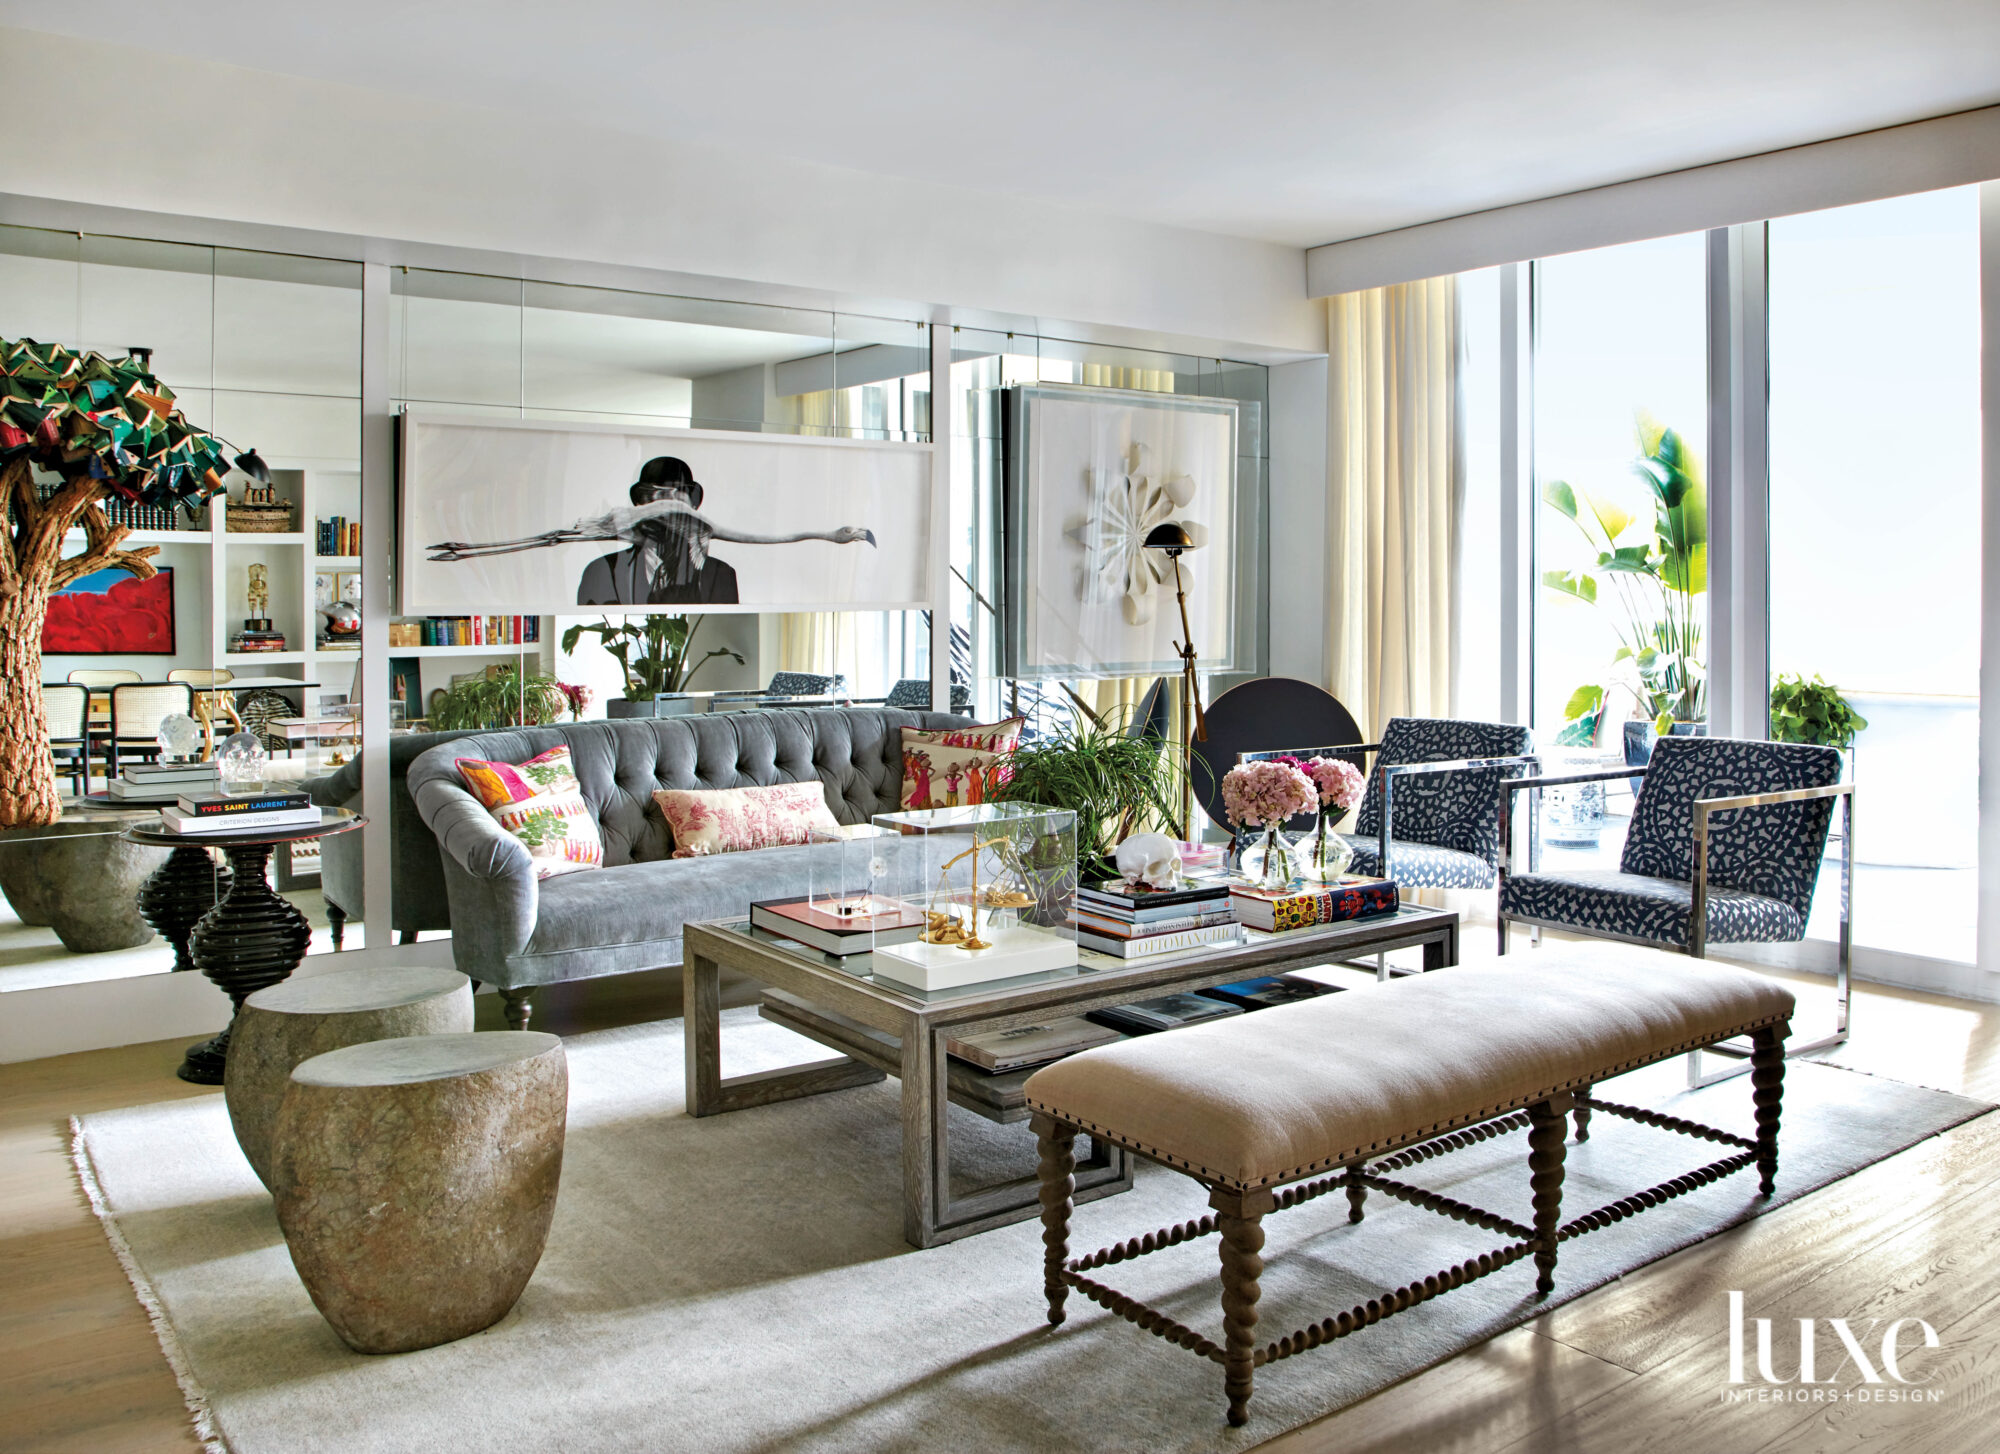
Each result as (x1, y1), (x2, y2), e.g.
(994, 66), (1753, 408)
(994, 716), (1186, 878)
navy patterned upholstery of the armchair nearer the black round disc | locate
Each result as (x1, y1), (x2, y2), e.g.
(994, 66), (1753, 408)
(1342, 716), (1534, 888)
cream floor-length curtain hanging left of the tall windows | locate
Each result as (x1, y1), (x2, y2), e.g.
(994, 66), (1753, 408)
(1326, 278), (1466, 738)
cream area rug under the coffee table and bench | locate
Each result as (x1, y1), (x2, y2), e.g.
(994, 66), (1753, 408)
(76, 1010), (1988, 1454)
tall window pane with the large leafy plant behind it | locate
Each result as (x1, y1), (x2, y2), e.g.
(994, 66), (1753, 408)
(1532, 234), (1708, 862)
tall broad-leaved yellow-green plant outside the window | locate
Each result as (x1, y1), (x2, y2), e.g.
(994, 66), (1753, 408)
(1542, 410), (1708, 746)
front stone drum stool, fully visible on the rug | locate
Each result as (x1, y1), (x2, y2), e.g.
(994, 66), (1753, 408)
(272, 1030), (570, 1354)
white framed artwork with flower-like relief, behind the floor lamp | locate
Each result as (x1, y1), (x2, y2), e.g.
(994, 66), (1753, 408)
(1002, 384), (1238, 682)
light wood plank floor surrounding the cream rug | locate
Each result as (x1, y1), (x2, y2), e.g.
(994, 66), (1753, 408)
(0, 960), (2000, 1454)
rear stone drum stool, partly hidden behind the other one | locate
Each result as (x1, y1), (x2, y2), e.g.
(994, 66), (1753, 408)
(222, 966), (472, 1186)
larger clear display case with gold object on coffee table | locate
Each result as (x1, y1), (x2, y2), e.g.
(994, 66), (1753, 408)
(874, 802), (1076, 990)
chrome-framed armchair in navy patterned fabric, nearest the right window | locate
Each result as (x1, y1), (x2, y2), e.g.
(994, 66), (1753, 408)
(1500, 736), (1854, 1086)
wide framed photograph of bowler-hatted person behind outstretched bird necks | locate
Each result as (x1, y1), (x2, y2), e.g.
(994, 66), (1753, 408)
(400, 414), (932, 616)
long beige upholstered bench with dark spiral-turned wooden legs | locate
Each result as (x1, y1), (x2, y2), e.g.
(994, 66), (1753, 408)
(1026, 944), (1792, 1424)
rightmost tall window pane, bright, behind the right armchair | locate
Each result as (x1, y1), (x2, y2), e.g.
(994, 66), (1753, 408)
(1770, 186), (1980, 962)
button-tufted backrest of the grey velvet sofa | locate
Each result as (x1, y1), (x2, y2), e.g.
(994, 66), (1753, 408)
(410, 708), (966, 866)
